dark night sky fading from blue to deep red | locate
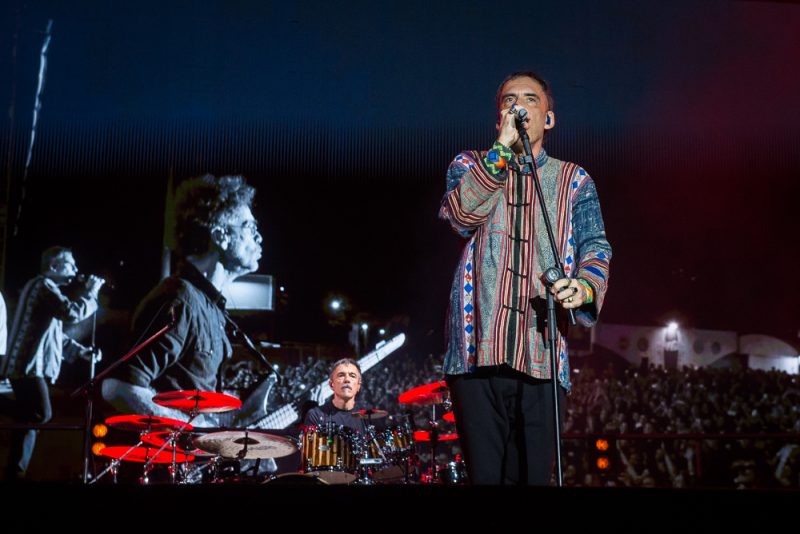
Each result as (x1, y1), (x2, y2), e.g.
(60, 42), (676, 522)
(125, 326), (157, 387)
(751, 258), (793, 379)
(0, 0), (800, 351)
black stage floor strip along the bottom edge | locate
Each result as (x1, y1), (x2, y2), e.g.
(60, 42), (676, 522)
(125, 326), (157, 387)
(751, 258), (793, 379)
(0, 481), (800, 534)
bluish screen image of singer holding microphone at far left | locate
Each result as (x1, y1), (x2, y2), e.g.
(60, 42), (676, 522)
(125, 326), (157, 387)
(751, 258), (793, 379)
(0, 247), (104, 480)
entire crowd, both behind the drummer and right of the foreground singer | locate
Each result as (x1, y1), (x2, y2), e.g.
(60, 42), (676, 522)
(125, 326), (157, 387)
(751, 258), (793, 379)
(230, 351), (800, 488)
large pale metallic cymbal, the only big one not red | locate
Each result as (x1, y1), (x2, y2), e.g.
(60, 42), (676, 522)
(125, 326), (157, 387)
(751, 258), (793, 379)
(194, 430), (297, 460)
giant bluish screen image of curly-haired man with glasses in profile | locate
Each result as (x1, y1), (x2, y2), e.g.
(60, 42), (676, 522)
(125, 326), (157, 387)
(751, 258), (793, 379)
(102, 175), (261, 432)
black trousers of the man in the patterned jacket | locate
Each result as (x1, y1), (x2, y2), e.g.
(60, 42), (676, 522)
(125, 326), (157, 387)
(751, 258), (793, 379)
(447, 365), (565, 486)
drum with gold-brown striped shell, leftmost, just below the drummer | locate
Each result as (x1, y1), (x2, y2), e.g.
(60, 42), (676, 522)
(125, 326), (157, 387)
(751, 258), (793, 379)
(300, 424), (357, 484)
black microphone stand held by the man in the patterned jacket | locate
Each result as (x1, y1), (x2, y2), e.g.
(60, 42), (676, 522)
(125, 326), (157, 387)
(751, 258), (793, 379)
(515, 114), (576, 488)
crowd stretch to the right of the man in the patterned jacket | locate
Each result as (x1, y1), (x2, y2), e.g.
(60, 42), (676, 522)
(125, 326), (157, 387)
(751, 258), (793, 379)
(564, 365), (800, 488)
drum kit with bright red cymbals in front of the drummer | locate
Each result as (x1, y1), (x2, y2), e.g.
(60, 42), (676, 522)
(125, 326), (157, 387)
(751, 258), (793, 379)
(92, 381), (466, 485)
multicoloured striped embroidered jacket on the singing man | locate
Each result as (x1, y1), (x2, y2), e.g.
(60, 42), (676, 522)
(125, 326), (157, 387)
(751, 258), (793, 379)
(439, 143), (611, 390)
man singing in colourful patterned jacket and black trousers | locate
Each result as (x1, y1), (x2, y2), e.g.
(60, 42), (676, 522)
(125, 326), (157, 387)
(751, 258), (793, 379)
(439, 72), (611, 485)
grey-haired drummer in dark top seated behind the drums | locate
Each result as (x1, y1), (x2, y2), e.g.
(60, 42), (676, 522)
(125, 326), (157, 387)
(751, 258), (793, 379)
(303, 358), (382, 433)
